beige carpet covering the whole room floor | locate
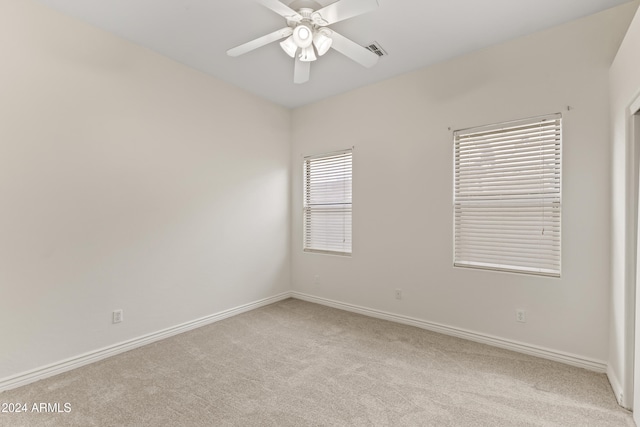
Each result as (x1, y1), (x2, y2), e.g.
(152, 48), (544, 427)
(0, 299), (634, 427)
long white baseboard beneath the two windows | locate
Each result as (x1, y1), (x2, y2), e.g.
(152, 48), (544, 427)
(292, 291), (607, 373)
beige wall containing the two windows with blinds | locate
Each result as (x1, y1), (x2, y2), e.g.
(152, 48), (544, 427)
(292, 4), (634, 369)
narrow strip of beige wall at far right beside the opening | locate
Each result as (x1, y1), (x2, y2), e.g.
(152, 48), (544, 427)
(608, 2), (640, 412)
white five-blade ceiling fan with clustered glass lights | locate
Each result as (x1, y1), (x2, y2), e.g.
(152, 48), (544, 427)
(227, 0), (378, 83)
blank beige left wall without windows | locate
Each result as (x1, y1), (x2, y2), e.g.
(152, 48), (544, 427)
(0, 0), (291, 380)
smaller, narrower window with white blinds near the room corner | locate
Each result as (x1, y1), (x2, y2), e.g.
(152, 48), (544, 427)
(303, 150), (352, 255)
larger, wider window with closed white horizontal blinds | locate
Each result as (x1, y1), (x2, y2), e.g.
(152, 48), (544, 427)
(454, 114), (562, 277)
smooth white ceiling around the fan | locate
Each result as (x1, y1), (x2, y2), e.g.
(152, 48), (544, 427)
(38, 0), (629, 107)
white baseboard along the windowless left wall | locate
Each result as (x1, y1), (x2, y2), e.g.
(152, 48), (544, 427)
(0, 292), (292, 393)
